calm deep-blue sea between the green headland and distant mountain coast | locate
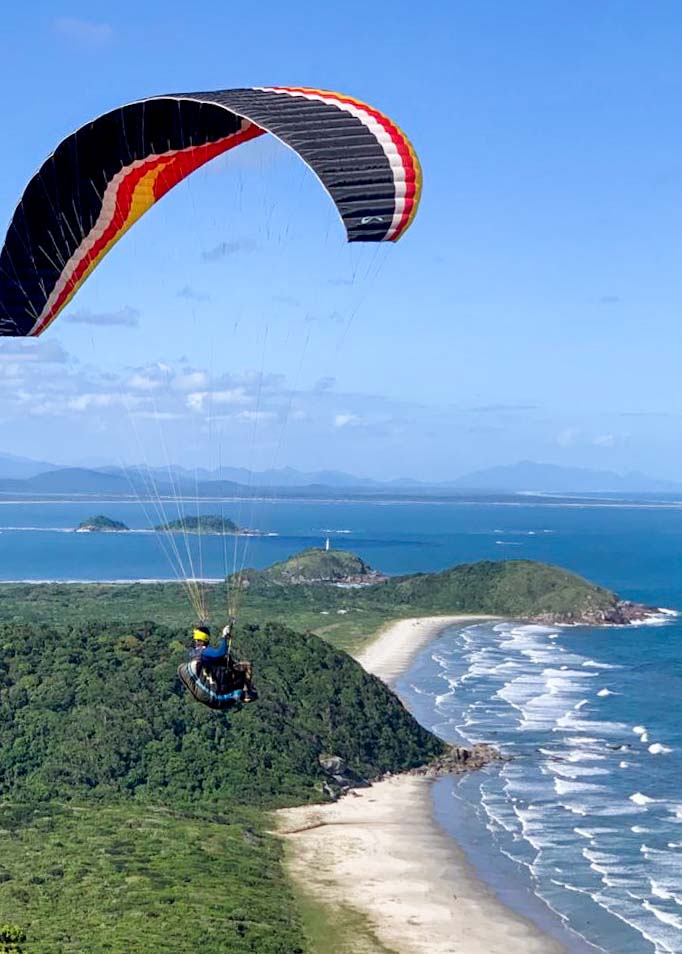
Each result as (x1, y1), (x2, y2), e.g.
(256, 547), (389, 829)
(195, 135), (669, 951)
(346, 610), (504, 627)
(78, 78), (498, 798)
(0, 497), (682, 588)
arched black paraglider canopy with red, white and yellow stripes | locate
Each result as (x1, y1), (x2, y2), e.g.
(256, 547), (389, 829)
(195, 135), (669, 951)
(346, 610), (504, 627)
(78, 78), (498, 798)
(0, 87), (421, 336)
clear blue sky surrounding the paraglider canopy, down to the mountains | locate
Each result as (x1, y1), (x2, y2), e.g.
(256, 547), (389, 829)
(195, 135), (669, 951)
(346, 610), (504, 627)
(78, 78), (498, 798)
(0, 0), (682, 479)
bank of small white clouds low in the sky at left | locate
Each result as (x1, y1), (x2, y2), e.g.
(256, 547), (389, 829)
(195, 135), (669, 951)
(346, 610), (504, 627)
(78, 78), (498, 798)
(0, 352), (414, 466)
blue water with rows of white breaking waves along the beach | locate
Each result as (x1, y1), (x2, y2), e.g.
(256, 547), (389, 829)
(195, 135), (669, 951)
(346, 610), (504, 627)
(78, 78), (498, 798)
(396, 616), (682, 954)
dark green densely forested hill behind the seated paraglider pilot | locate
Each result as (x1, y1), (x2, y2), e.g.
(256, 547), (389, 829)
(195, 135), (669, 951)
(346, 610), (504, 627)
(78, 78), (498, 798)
(0, 612), (442, 807)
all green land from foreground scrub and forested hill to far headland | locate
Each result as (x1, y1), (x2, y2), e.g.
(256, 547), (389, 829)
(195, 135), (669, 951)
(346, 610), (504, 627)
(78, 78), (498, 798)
(0, 550), (617, 954)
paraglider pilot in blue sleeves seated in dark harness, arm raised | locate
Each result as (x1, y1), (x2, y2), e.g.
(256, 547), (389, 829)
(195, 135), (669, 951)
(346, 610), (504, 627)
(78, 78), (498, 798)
(178, 621), (257, 709)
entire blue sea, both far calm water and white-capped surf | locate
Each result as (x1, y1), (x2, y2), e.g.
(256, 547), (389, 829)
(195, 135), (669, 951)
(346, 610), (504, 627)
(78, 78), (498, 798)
(0, 498), (682, 954)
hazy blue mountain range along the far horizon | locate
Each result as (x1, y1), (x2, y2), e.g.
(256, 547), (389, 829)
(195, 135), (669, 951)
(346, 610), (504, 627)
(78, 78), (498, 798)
(0, 454), (682, 497)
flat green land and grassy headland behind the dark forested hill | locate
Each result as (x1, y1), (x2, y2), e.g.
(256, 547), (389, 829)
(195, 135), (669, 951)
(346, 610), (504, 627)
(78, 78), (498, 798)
(0, 551), (617, 650)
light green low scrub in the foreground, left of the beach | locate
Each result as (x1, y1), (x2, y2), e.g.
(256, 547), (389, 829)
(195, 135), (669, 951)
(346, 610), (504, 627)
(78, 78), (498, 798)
(0, 803), (300, 954)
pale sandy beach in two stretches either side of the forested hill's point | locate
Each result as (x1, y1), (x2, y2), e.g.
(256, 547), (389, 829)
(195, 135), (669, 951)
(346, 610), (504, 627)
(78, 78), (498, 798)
(278, 616), (564, 954)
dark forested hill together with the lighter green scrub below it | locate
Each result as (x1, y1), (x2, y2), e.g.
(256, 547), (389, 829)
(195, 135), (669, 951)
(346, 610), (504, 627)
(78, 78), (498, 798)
(0, 606), (443, 954)
